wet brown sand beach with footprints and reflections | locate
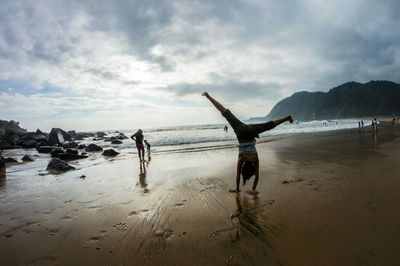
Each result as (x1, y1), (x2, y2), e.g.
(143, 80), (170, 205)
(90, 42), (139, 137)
(0, 124), (400, 265)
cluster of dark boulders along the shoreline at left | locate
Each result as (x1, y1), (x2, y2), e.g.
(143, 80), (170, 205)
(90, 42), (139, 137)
(0, 125), (123, 176)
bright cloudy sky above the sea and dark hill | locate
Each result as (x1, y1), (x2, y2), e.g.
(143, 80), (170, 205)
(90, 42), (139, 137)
(0, 0), (400, 130)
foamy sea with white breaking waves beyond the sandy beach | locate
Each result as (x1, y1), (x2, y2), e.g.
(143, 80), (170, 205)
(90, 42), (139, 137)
(81, 119), (370, 152)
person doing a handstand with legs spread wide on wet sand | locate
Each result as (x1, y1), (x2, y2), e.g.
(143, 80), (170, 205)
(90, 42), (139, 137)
(203, 92), (293, 195)
